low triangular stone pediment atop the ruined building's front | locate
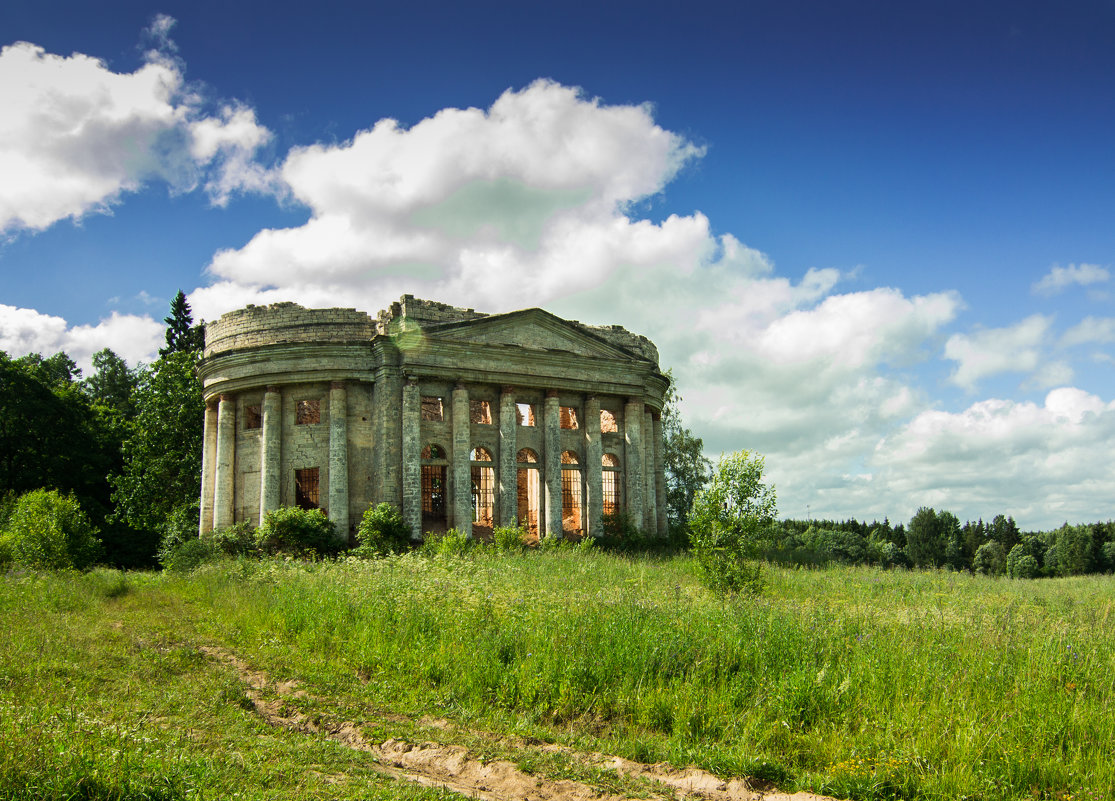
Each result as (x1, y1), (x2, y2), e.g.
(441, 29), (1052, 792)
(425, 309), (640, 360)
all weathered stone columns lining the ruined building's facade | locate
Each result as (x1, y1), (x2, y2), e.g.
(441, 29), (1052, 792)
(200, 377), (667, 538)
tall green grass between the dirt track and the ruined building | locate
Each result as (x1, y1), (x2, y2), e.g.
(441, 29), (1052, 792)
(174, 550), (1115, 801)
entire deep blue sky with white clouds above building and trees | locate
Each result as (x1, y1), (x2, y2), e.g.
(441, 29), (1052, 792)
(0, 0), (1115, 528)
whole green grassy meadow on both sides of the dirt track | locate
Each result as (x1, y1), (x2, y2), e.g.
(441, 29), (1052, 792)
(0, 549), (1115, 801)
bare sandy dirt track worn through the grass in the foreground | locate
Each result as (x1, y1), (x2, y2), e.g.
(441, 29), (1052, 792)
(201, 646), (836, 801)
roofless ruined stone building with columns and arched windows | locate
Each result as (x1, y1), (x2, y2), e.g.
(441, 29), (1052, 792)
(200, 296), (668, 538)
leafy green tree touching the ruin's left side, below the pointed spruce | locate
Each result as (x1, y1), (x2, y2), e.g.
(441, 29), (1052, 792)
(112, 350), (205, 532)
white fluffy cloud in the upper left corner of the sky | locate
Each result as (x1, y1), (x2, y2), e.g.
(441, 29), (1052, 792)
(0, 17), (270, 232)
